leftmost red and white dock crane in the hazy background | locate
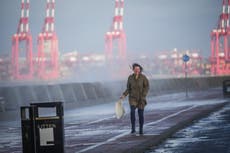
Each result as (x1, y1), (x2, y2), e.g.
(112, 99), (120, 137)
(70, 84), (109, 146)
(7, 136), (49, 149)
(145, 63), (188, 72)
(11, 0), (33, 80)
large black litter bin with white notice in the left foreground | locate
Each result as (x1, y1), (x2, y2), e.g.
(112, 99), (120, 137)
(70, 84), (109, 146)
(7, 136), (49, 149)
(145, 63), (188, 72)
(21, 102), (64, 153)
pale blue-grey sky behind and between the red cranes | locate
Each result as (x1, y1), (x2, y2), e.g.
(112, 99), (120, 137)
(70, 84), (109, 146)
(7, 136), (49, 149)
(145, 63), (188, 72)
(0, 0), (219, 56)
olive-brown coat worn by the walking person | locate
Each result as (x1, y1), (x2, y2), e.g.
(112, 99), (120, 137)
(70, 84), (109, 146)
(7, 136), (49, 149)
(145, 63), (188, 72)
(123, 74), (149, 109)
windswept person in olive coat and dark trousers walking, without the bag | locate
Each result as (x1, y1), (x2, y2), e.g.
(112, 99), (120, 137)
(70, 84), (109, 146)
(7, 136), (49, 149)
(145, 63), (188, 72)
(121, 63), (149, 134)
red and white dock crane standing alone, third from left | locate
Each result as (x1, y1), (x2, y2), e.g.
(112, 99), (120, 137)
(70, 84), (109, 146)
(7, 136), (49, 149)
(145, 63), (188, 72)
(105, 0), (126, 60)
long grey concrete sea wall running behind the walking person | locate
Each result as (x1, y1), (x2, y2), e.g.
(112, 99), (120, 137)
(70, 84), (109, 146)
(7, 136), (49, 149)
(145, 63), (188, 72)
(0, 76), (230, 111)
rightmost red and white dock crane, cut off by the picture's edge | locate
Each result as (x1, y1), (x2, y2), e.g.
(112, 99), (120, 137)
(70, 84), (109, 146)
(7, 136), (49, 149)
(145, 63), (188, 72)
(210, 0), (230, 75)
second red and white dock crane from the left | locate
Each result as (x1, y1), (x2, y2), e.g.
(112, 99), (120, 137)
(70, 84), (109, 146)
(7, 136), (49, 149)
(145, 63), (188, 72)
(38, 0), (59, 79)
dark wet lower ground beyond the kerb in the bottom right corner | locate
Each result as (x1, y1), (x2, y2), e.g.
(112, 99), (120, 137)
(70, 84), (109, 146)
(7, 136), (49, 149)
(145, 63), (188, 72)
(146, 104), (230, 153)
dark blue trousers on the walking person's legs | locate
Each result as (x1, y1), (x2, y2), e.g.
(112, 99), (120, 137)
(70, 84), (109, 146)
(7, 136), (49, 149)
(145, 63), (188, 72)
(130, 106), (144, 132)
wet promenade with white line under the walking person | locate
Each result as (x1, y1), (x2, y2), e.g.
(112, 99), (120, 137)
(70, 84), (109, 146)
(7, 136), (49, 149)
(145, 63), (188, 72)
(0, 88), (229, 153)
